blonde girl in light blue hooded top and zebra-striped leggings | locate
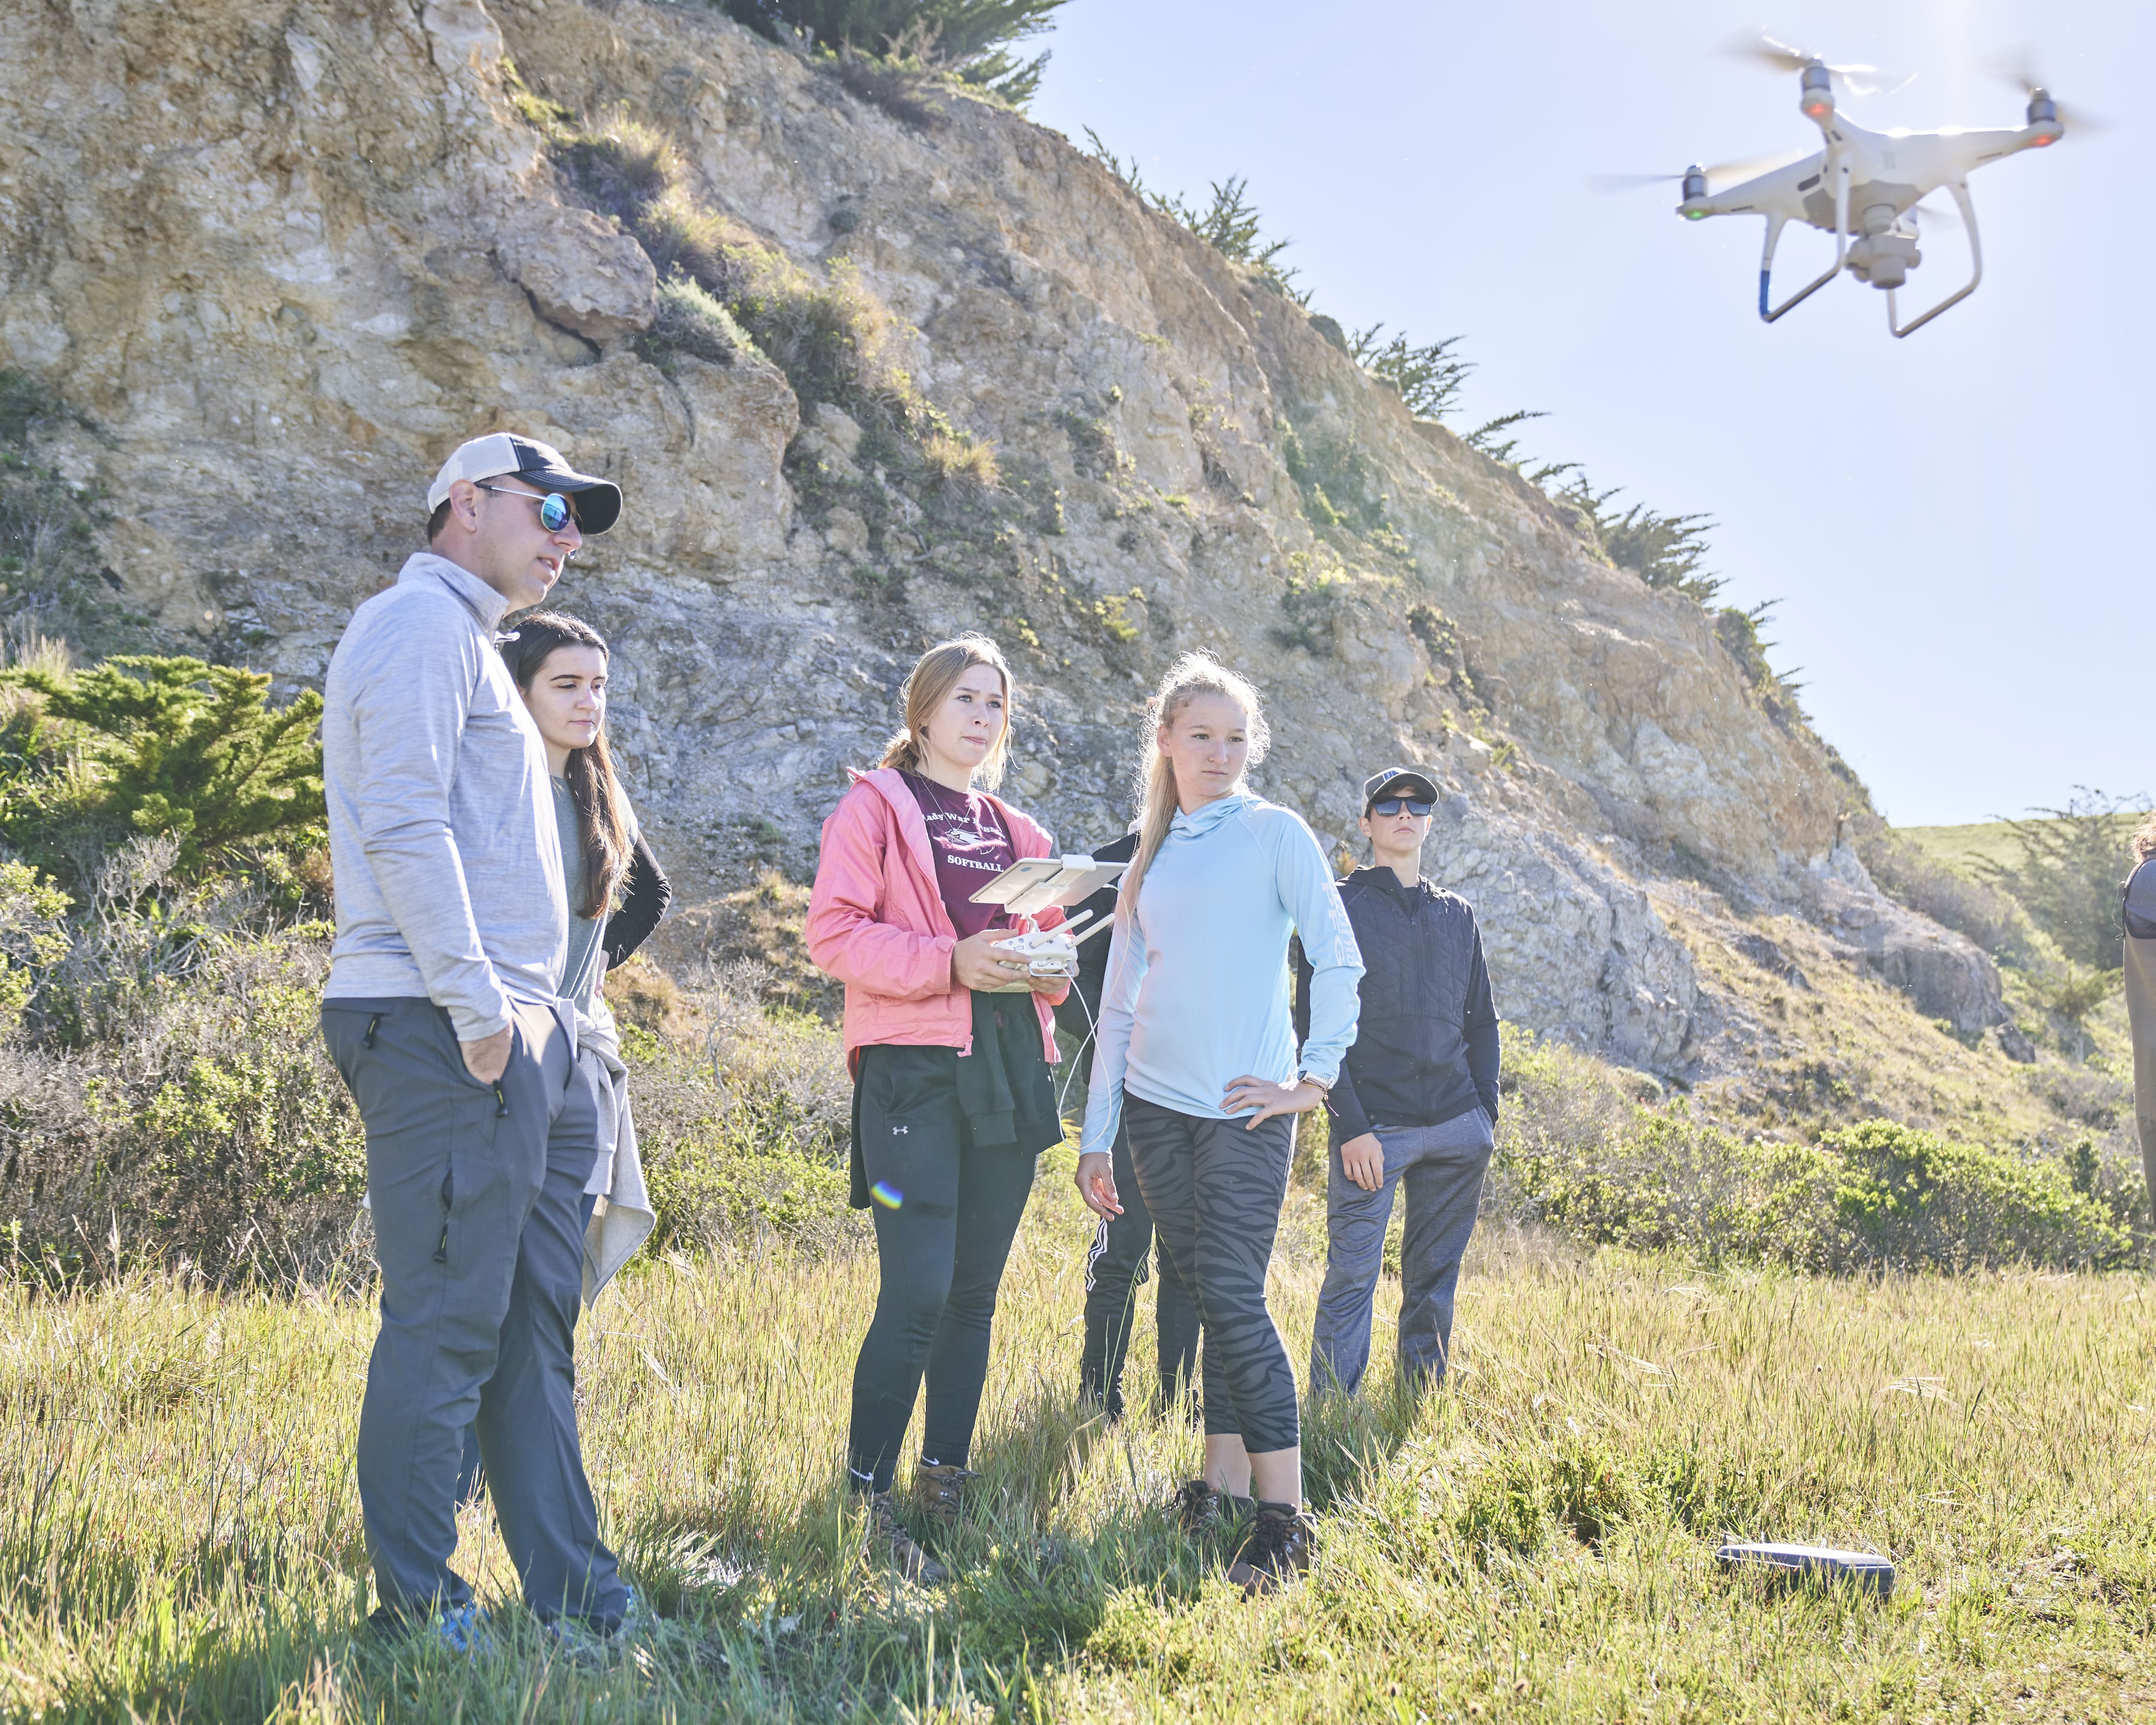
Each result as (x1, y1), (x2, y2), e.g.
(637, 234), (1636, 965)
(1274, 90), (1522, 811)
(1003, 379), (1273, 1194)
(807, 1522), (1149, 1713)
(1078, 653), (1362, 1593)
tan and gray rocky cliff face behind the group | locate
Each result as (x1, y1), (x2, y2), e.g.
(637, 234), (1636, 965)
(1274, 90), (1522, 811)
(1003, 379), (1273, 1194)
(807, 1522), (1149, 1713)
(0, 0), (1997, 1072)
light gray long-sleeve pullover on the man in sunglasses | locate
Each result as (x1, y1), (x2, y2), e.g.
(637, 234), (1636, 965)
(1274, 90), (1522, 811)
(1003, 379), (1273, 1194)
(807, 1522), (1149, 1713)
(321, 552), (569, 1042)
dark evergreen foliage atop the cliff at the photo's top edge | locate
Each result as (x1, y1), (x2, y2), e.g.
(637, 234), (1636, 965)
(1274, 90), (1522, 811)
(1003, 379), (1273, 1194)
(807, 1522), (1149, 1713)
(720, 0), (1065, 108)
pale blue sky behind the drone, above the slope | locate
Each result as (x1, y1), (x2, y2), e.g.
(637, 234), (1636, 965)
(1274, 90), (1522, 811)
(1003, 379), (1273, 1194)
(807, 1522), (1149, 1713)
(1032, 0), (2156, 826)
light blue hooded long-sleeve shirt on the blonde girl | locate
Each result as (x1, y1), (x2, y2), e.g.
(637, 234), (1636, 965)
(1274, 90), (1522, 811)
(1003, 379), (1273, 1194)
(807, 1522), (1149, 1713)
(1080, 791), (1362, 1151)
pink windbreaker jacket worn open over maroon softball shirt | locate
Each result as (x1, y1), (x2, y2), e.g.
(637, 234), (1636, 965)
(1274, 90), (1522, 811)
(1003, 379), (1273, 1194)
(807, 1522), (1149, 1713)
(804, 768), (1063, 1067)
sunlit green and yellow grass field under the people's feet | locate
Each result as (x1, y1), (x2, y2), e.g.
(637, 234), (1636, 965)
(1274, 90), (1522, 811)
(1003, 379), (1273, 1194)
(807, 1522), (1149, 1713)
(0, 1154), (2156, 1725)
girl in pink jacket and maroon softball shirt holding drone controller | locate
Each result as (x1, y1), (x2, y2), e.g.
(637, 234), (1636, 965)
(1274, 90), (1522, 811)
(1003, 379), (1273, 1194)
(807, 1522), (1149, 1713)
(806, 634), (1070, 1581)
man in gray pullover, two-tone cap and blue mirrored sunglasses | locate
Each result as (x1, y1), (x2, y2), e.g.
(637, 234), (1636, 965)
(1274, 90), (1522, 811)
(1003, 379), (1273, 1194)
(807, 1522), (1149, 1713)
(321, 434), (629, 1650)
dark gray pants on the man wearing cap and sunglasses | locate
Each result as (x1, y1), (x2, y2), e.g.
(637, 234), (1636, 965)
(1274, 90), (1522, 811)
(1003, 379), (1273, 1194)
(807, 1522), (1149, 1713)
(321, 998), (628, 1630)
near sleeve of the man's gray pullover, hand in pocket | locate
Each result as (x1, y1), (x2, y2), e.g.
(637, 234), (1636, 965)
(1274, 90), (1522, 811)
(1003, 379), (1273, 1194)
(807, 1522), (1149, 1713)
(352, 621), (509, 1042)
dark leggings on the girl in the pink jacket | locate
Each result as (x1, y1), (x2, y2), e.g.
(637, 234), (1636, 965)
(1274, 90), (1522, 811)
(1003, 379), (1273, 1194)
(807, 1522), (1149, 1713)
(847, 1046), (1035, 1492)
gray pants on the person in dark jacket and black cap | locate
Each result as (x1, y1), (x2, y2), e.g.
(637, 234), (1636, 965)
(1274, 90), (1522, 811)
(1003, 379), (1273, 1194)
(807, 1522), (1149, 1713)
(1311, 1108), (1492, 1395)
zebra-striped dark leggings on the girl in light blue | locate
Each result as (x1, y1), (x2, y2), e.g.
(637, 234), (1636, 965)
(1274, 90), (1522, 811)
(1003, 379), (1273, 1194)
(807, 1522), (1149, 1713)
(1124, 1093), (1302, 1455)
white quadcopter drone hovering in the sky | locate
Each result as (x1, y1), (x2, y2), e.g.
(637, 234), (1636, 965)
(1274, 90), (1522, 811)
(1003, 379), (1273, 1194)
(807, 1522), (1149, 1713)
(1639, 37), (2066, 337)
